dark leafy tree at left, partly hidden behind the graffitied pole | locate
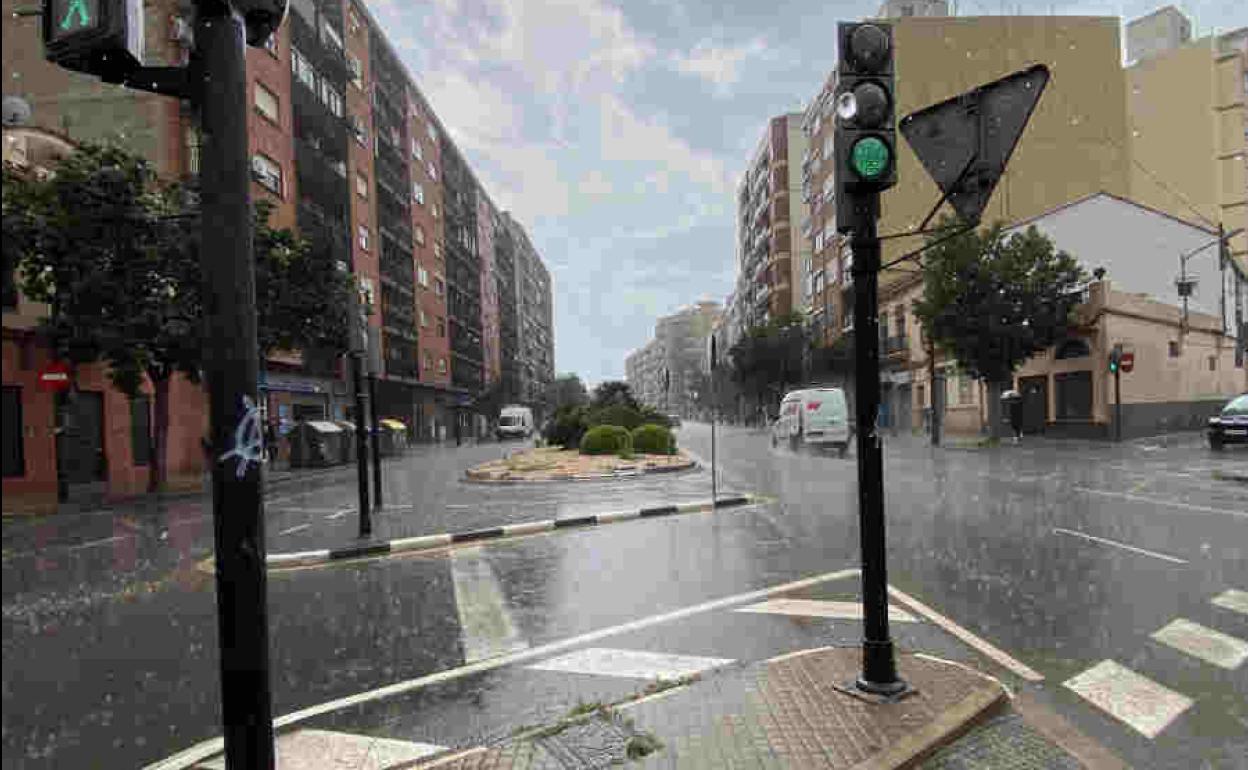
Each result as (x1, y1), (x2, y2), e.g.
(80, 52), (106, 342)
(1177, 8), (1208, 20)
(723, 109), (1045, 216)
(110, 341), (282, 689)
(4, 144), (354, 490)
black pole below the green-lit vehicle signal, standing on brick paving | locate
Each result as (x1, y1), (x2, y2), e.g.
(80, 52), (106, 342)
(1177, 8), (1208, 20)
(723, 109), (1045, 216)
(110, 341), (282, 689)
(850, 192), (906, 695)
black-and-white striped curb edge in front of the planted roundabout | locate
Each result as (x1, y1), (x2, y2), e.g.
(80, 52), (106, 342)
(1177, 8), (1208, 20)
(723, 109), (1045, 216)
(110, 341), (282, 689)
(265, 494), (763, 569)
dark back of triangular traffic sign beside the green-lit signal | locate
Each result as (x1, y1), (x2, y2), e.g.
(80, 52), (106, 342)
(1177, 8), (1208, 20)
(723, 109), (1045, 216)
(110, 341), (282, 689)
(900, 64), (1048, 222)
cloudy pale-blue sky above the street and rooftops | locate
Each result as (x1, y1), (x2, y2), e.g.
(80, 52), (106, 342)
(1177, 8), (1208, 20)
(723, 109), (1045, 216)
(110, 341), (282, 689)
(366, 0), (1248, 382)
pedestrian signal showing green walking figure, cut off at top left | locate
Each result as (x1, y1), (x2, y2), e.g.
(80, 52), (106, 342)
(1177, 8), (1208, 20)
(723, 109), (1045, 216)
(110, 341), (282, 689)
(42, 0), (144, 82)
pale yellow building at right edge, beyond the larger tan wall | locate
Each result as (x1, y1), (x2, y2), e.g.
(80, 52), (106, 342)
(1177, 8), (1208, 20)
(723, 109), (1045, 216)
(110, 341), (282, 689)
(1126, 27), (1248, 265)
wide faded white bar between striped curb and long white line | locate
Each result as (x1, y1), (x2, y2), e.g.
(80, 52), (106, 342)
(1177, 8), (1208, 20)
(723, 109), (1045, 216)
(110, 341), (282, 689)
(451, 548), (529, 663)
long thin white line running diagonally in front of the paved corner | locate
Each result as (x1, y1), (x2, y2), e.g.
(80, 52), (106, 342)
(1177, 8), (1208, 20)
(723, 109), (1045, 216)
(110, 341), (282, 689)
(145, 568), (858, 770)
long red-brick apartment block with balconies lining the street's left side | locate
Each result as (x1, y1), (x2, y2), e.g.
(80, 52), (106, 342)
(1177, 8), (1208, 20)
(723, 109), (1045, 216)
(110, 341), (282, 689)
(4, 0), (554, 509)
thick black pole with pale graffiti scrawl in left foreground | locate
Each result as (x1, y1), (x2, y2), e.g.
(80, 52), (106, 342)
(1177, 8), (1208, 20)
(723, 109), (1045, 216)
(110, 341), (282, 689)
(191, 0), (273, 770)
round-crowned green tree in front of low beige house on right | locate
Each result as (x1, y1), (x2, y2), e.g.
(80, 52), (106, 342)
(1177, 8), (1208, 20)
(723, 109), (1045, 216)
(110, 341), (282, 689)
(915, 217), (1087, 437)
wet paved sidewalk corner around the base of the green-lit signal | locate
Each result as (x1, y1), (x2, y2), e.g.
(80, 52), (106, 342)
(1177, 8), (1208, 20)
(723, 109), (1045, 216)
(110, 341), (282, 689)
(321, 646), (1083, 770)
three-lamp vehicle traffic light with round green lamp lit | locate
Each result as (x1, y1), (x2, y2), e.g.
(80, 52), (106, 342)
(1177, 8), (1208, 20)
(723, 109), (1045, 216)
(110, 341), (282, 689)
(832, 21), (897, 232)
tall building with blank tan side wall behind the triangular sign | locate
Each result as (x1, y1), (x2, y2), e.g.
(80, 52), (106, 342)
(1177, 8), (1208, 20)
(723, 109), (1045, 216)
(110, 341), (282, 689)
(802, 16), (1129, 342)
